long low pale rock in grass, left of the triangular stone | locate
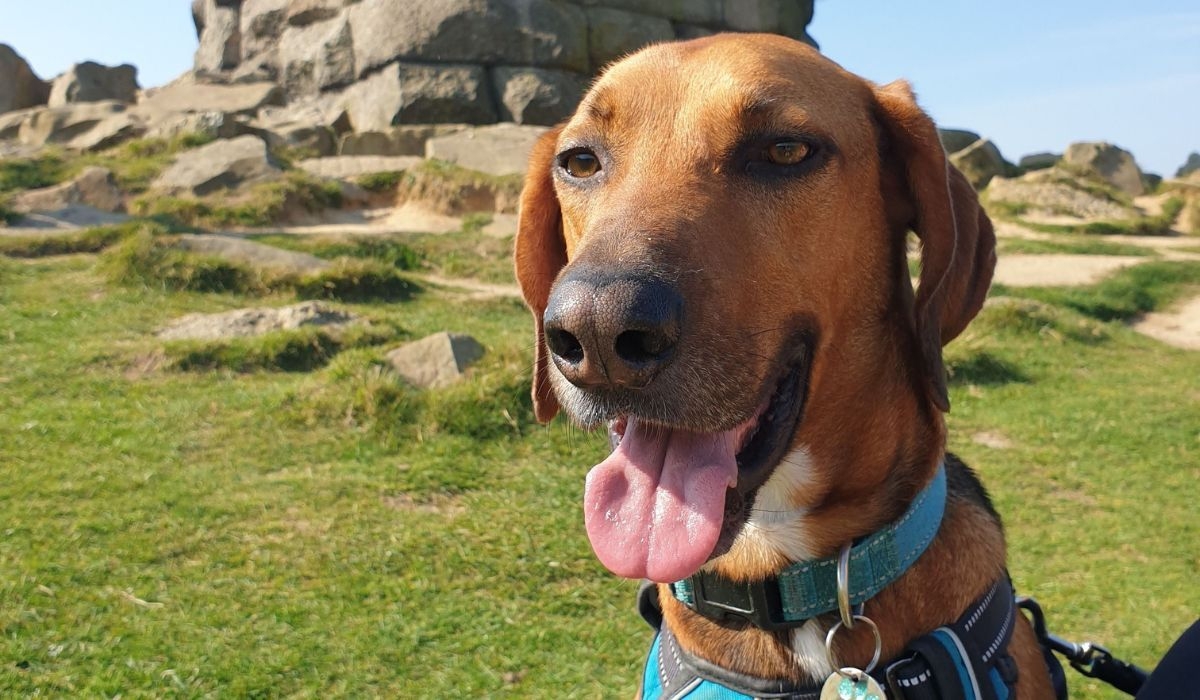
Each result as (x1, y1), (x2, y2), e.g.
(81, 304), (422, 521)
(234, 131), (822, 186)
(156, 301), (359, 340)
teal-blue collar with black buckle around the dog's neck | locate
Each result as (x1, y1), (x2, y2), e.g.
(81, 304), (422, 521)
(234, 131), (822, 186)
(670, 465), (946, 629)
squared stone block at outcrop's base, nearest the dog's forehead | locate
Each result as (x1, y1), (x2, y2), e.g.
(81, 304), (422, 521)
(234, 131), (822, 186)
(492, 67), (588, 126)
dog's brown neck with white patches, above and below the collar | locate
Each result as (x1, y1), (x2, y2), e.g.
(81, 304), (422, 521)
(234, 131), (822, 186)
(660, 326), (955, 682)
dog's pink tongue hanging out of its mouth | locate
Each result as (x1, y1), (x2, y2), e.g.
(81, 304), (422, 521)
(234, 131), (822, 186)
(583, 418), (745, 582)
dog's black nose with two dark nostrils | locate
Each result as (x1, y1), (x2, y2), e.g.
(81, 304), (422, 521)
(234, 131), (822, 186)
(542, 270), (683, 389)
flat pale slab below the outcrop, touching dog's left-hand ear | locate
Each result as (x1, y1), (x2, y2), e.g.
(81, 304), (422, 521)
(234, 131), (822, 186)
(425, 124), (546, 175)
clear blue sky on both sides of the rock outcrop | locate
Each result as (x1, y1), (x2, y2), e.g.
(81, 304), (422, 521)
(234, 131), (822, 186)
(0, 0), (1200, 174)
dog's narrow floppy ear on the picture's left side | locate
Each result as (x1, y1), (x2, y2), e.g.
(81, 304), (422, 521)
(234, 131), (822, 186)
(512, 128), (566, 423)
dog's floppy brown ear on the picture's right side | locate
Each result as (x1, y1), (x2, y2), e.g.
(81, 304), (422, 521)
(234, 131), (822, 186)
(875, 80), (996, 411)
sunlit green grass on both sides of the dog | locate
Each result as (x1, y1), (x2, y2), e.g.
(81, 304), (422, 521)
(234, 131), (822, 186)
(0, 244), (1200, 700)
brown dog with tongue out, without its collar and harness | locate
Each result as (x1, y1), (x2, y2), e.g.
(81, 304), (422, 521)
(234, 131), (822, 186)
(516, 35), (1051, 698)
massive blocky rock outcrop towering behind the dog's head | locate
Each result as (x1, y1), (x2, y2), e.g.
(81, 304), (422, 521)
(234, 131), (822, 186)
(192, 0), (815, 132)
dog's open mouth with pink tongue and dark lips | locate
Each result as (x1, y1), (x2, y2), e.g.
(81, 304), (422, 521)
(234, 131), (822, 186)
(584, 343), (810, 582)
